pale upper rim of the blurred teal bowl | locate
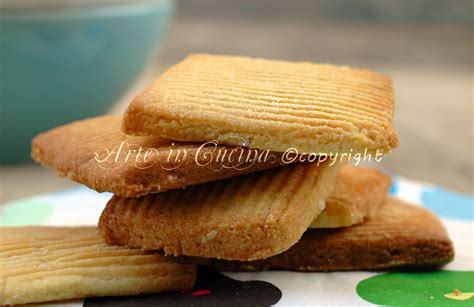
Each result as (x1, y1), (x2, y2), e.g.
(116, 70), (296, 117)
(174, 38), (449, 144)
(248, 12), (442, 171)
(0, 0), (175, 21)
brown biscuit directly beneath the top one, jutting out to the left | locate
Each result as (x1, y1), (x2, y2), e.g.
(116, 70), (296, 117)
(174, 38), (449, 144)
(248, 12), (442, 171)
(32, 116), (282, 197)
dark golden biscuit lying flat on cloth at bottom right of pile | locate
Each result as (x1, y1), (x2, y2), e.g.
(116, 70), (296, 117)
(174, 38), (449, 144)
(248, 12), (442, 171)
(204, 198), (454, 271)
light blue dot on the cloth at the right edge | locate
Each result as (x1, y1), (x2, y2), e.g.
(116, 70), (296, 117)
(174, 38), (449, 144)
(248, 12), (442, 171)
(421, 188), (474, 220)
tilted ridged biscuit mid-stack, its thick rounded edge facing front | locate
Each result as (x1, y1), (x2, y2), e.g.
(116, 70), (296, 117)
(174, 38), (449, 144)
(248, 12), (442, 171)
(99, 162), (340, 260)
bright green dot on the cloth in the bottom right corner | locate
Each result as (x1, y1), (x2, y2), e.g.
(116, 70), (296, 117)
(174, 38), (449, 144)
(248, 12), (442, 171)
(356, 270), (474, 306)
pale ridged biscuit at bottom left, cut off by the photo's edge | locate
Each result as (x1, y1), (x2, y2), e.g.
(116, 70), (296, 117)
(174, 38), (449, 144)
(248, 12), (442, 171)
(0, 227), (196, 305)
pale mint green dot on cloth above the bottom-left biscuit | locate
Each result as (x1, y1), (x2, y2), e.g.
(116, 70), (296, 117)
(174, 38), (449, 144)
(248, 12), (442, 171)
(0, 200), (53, 226)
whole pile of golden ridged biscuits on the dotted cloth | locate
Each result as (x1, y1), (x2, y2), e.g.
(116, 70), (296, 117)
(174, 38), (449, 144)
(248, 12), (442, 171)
(0, 55), (453, 304)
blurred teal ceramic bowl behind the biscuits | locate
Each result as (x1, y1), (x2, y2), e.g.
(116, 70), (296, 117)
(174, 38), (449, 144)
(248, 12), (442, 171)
(0, 0), (174, 163)
